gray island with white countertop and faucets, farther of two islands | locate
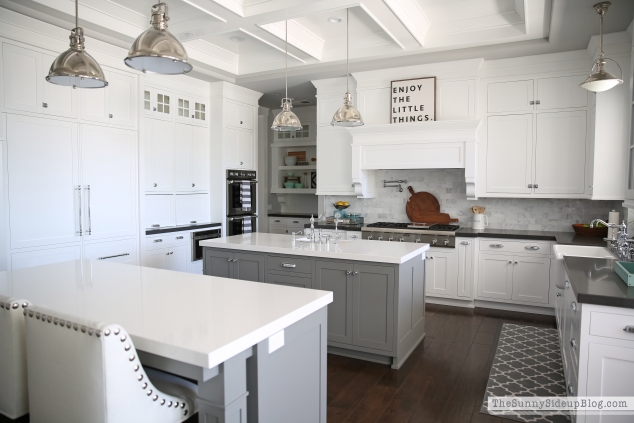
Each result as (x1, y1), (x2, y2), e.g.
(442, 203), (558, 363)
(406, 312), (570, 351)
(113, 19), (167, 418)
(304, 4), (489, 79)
(201, 233), (429, 369)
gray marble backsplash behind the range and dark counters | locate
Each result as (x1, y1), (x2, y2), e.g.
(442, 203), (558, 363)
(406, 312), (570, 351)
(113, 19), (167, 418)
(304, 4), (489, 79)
(324, 169), (623, 232)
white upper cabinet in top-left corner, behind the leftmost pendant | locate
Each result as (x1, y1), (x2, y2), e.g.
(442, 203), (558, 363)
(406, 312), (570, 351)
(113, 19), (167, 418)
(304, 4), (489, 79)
(2, 43), (78, 118)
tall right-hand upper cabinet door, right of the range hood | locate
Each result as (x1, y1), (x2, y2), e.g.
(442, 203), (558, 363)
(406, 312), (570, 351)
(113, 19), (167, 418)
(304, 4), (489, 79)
(533, 111), (586, 194)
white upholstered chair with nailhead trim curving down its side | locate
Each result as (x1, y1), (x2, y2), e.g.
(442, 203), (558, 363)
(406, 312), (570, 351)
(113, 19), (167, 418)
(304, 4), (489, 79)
(26, 306), (195, 423)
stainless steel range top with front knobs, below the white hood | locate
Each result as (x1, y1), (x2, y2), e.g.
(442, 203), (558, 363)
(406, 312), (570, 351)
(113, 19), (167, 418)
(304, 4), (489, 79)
(361, 222), (460, 248)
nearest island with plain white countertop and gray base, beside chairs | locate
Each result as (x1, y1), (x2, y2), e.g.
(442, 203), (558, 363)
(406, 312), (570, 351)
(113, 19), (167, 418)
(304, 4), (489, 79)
(0, 260), (332, 423)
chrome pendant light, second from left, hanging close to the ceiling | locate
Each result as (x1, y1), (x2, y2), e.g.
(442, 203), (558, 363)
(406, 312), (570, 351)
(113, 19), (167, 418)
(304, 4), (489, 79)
(124, 3), (193, 75)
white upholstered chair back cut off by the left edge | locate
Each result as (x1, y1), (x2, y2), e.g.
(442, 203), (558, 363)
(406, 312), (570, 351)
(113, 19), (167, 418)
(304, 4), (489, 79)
(0, 295), (29, 419)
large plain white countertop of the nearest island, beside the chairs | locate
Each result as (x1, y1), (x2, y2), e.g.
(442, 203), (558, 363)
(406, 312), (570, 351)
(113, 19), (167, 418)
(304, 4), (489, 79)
(0, 260), (332, 368)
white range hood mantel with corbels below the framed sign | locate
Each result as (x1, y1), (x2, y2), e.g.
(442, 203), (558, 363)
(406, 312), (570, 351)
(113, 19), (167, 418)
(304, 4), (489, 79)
(346, 119), (480, 200)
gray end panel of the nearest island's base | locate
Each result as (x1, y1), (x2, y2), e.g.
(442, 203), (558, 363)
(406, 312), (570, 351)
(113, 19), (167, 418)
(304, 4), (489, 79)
(247, 307), (328, 423)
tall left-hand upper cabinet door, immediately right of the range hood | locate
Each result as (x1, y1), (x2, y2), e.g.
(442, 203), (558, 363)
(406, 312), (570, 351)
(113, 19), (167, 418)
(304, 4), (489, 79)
(486, 114), (532, 194)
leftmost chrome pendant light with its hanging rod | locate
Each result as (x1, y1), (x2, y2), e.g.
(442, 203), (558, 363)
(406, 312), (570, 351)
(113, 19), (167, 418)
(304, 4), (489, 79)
(46, 0), (108, 88)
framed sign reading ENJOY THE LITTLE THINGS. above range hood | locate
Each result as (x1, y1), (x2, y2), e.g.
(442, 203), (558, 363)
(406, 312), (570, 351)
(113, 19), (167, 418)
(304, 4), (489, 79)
(390, 76), (436, 123)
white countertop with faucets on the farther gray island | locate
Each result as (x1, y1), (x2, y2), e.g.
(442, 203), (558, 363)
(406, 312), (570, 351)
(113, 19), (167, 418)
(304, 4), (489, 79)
(200, 232), (429, 264)
